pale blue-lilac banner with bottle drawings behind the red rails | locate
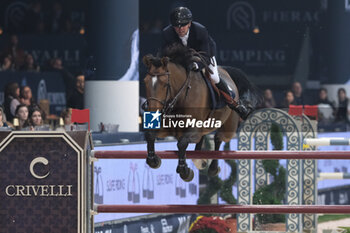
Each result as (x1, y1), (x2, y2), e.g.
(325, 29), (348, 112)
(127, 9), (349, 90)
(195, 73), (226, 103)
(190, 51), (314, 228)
(94, 142), (199, 223)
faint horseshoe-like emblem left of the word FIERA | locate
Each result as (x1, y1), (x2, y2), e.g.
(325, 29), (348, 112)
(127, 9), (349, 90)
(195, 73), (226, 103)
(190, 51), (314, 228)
(226, 1), (256, 30)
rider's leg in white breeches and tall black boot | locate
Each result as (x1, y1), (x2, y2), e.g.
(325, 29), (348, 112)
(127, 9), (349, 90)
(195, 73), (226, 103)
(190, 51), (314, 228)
(209, 57), (251, 120)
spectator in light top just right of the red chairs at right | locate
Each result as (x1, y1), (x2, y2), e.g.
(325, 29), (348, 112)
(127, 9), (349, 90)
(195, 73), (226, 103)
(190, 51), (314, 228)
(316, 88), (335, 122)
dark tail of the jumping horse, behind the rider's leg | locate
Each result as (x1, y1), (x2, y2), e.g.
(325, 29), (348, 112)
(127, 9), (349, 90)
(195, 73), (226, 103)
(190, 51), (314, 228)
(222, 66), (263, 108)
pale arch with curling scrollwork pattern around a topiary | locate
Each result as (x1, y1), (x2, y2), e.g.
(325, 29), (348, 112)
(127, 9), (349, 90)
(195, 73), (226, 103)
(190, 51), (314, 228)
(237, 109), (302, 232)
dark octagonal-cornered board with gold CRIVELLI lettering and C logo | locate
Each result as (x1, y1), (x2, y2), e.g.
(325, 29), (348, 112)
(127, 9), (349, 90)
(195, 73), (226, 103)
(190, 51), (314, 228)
(0, 131), (88, 233)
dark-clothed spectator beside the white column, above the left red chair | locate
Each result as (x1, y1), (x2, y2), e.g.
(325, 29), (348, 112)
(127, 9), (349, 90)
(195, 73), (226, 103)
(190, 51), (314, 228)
(67, 74), (85, 109)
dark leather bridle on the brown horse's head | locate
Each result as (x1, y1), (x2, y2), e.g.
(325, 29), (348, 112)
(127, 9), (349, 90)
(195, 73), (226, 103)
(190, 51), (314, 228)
(142, 68), (191, 114)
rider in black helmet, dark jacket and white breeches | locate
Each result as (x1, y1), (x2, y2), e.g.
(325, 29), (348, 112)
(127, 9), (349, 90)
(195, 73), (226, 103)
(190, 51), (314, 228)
(162, 7), (250, 120)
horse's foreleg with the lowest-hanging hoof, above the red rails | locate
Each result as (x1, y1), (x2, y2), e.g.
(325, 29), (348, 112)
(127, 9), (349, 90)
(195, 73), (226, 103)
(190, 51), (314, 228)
(176, 136), (194, 182)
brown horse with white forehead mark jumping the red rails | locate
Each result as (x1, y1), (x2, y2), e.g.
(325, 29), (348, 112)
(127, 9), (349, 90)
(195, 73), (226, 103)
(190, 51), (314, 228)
(143, 46), (261, 182)
